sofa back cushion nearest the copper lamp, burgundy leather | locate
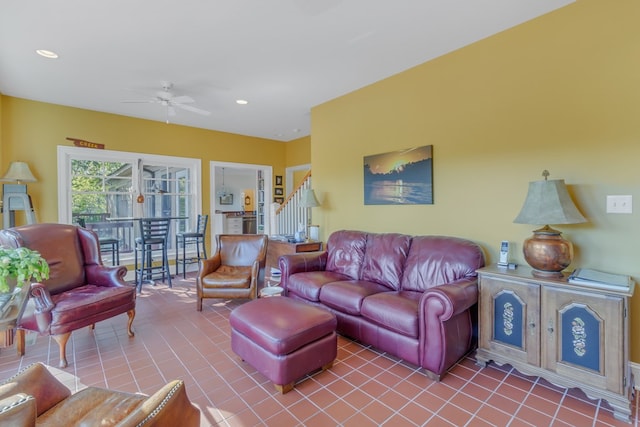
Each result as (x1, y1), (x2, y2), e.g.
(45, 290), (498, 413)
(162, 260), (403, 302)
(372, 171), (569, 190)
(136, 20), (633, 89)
(400, 236), (484, 292)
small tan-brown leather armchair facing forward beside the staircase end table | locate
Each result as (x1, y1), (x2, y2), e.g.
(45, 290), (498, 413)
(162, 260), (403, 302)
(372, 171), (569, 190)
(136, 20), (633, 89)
(196, 234), (268, 311)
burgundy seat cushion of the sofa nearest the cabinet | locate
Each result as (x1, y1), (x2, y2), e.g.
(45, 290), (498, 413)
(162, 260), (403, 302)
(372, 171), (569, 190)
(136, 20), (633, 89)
(360, 291), (422, 338)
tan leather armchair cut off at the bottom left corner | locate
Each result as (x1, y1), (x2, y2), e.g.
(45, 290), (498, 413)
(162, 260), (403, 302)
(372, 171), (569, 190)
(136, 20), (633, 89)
(0, 363), (200, 427)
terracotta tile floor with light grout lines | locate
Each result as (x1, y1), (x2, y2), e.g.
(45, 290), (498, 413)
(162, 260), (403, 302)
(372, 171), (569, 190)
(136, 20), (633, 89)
(0, 278), (638, 427)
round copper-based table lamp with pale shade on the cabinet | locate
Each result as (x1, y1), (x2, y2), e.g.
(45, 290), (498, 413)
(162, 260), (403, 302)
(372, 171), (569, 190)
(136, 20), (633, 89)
(513, 170), (587, 277)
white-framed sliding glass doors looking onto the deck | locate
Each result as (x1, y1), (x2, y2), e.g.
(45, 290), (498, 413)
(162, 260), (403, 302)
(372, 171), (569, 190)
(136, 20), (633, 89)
(58, 146), (202, 259)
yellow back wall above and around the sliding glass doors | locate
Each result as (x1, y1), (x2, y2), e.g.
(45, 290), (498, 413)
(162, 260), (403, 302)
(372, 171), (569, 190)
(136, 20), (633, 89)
(0, 96), (286, 222)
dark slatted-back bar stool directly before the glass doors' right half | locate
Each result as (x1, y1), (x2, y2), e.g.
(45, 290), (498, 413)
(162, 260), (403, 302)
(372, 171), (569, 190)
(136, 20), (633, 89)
(134, 218), (172, 292)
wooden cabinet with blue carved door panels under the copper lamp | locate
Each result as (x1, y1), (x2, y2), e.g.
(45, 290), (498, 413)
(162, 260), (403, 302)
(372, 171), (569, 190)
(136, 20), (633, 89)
(476, 267), (635, 421)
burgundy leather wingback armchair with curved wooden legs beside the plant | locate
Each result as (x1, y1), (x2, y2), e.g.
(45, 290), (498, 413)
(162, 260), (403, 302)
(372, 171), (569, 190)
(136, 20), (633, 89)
(0, 224), (136, 368)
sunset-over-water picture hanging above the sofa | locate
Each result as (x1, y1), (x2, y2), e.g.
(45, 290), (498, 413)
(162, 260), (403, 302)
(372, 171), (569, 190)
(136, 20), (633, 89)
(364, 145), (433, 205)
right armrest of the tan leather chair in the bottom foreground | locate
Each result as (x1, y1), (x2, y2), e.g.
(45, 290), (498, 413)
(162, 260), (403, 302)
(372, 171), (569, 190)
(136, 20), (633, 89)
(118, 380), (200, 427)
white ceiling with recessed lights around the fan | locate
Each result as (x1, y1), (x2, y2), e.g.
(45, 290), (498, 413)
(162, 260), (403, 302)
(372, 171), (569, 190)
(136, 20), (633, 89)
(0, 0), (572, 141)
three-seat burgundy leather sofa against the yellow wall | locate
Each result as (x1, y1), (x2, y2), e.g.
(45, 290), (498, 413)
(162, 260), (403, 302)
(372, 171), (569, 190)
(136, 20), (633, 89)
(279, 230), (485, 380)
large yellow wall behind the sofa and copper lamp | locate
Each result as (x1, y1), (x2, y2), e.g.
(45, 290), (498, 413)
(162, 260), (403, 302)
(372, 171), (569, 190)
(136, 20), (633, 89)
(311, 0), (640, 361)
